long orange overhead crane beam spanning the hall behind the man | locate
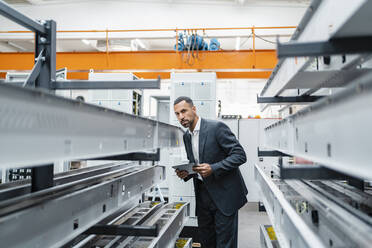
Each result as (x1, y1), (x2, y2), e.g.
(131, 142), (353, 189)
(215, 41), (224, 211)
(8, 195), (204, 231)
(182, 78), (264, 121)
(0, 50), (277, 78)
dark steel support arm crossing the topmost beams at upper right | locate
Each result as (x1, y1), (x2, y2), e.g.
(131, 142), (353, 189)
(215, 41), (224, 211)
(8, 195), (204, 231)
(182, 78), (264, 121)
(277, 36), (372, 58)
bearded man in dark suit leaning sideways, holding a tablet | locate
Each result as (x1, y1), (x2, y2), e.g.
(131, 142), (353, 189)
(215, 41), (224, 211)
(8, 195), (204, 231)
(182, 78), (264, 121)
(174, 96), (248, 248)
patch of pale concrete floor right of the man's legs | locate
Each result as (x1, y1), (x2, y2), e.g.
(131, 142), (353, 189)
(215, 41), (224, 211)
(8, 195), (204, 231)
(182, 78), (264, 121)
(238, 203), (270, 248)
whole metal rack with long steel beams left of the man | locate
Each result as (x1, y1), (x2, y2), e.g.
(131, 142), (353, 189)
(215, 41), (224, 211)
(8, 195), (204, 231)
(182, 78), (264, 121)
(0, 1), (189, 247)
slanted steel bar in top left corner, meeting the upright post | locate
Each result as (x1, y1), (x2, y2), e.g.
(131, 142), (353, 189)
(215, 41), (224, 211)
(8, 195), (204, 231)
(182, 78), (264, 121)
(0, 1), (46, 34)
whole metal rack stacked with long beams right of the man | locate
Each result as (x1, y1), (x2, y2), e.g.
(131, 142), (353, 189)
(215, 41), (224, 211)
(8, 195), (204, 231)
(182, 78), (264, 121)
(255, 0), (372, 247)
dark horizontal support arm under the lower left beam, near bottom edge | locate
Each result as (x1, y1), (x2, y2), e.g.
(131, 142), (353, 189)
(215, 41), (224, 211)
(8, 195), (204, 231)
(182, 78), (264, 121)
(83, 225), (159, 237)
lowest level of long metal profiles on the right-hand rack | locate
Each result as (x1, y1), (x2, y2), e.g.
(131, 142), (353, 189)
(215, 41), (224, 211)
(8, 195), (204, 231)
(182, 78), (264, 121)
(255, 165), (372, 248)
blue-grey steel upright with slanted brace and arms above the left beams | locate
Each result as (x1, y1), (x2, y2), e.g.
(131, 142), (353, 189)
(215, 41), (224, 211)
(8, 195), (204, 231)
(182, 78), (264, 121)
(0, 0), (160, 91)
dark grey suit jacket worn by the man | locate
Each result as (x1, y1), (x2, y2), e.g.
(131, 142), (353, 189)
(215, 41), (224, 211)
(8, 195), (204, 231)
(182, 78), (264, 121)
(183, 119), (248, 216)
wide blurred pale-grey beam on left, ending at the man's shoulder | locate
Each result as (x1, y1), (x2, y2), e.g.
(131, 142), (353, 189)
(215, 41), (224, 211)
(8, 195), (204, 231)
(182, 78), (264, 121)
(0, 84), (183, 168)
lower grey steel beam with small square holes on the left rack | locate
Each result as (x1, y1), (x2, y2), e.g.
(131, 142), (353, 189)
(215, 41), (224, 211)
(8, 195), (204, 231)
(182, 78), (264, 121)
(0, 166), (164, 247)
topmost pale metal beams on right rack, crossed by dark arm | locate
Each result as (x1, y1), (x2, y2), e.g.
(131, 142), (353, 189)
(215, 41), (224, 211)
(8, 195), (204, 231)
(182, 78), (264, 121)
(261, 0), (372, 102)
